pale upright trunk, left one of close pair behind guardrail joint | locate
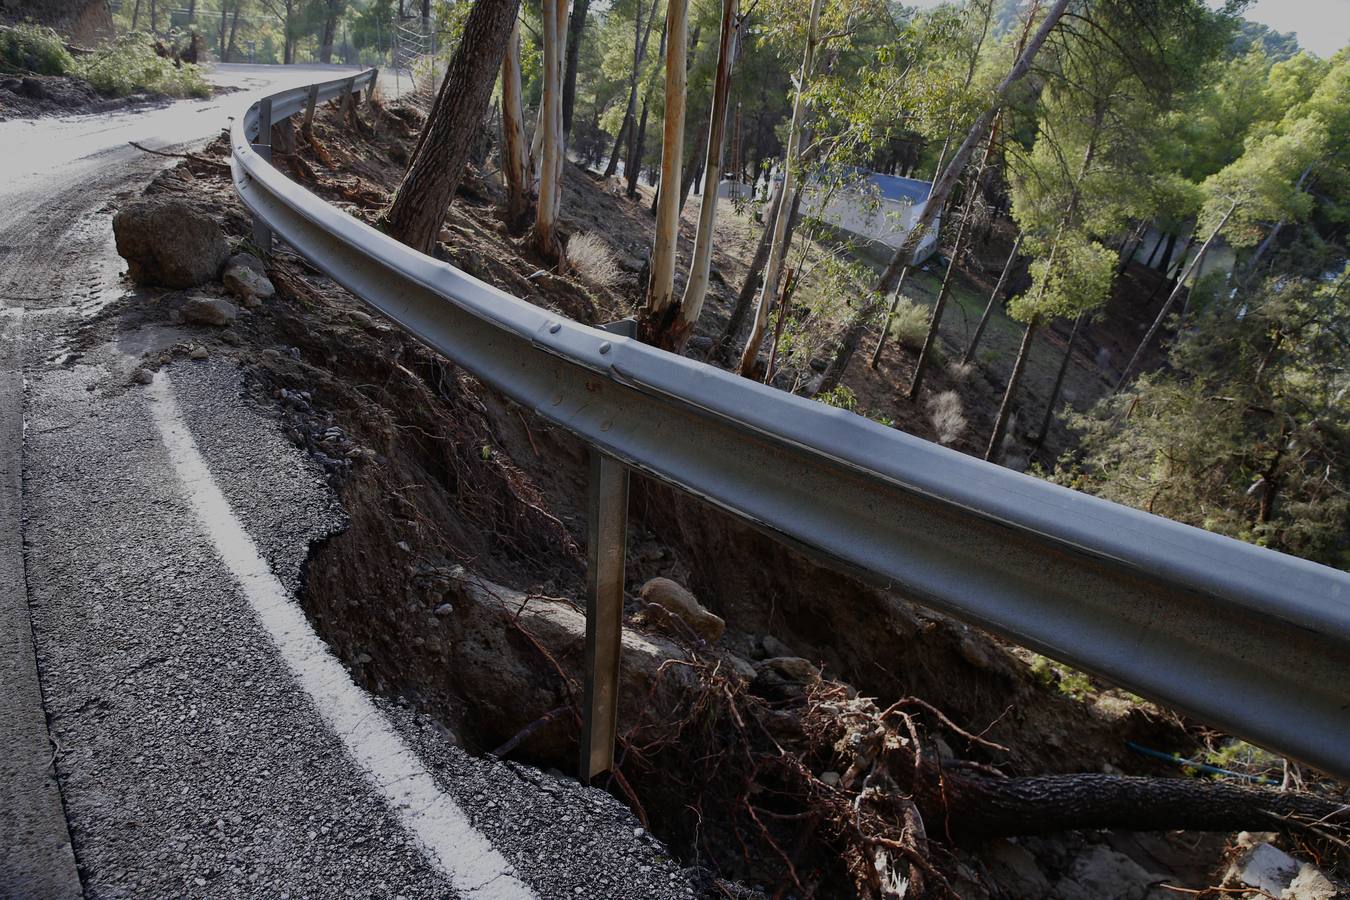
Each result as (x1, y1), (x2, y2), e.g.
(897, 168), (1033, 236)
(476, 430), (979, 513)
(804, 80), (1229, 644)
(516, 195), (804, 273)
(643, 0), (689, 334)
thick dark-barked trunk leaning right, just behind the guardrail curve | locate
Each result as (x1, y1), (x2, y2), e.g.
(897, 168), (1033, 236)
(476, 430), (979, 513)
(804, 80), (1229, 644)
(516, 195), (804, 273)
(381, 0), (520, 254)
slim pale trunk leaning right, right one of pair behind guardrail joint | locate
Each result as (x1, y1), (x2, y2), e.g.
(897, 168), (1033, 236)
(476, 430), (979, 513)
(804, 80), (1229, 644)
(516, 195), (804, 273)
(656, 0), (739, 354)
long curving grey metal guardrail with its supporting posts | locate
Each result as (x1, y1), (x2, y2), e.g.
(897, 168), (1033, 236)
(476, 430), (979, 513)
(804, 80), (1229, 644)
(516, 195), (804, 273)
(231, 73), (1350, 779)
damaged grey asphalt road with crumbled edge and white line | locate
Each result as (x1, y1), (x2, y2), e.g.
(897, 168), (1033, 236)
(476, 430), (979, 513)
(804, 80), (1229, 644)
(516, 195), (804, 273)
(0, 66), (691, 897)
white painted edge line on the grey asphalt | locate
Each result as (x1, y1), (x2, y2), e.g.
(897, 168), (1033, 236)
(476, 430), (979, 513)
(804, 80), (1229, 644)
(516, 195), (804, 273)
(147, 372), (535, 900)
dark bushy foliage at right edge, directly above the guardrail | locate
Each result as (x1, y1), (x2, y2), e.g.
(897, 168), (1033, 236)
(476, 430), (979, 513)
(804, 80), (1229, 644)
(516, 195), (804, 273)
(1054, 266), (1350, 568)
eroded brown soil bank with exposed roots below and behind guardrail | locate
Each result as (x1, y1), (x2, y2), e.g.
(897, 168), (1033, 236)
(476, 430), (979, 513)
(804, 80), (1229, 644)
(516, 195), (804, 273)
(89, 95), (1331, 897)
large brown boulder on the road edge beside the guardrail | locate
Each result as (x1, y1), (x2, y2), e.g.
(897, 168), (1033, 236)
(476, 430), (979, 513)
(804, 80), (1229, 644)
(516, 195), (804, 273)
(112, 198), (230, 287)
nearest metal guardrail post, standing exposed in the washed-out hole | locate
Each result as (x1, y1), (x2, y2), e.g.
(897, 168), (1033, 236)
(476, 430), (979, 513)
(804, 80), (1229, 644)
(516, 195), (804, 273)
(581, 448), (628, 784)
